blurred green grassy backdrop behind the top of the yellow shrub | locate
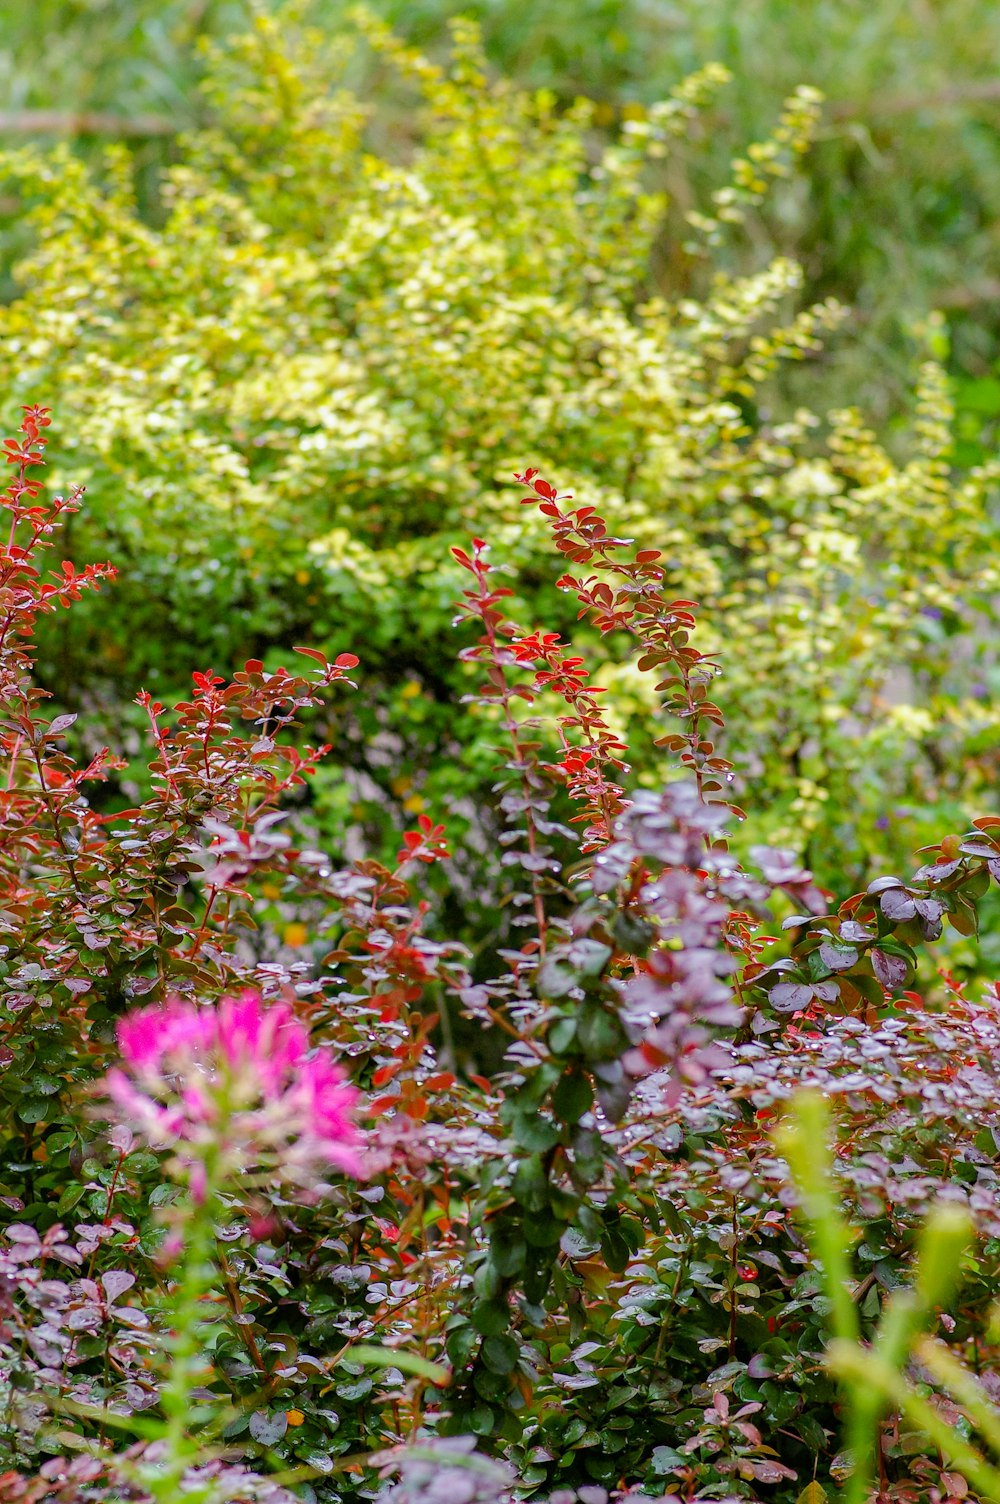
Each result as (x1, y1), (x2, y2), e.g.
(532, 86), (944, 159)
(0, 0), (1000, 430)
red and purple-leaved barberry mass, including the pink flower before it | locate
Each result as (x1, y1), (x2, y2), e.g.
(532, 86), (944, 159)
(0, 408), (1000, 1504)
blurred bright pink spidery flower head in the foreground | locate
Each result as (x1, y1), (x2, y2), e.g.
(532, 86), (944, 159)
(104, 991), (362, 1194)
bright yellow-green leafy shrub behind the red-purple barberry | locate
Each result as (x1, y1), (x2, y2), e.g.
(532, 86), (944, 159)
(0, 11), (997, 886)
